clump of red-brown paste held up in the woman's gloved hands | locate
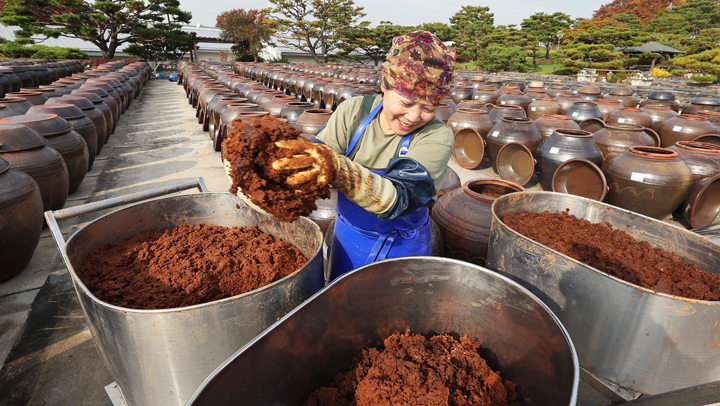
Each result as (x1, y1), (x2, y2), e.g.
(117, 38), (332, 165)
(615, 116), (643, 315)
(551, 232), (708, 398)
(223, 116), (330, 222)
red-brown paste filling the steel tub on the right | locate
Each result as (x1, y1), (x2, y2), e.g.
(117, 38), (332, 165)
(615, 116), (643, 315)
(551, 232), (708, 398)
(503, 211), (720, 301)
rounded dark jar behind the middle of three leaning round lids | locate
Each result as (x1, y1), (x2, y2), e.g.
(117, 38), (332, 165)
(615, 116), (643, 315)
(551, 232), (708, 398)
(485, 116), (542, 172)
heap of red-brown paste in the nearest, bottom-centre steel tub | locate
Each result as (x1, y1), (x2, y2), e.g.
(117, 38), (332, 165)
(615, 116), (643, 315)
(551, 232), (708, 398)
(304, 331), (518, 406)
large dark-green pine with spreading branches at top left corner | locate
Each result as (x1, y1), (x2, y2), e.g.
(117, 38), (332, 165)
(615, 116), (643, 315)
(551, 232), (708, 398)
(0, 0), (192, 59)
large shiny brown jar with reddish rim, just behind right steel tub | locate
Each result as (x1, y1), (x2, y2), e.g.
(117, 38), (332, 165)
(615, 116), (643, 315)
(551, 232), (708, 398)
(605, 146), (693, 219)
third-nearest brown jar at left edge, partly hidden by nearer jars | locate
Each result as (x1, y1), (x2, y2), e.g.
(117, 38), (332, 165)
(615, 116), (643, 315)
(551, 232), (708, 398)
(0, 114), (90, 195)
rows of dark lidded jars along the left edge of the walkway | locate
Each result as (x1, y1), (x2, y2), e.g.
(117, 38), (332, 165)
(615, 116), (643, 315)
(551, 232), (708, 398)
(0, 61), (152, 283)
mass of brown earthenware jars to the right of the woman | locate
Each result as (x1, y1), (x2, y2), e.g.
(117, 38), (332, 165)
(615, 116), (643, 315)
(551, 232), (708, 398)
(431, 77), (720, 265)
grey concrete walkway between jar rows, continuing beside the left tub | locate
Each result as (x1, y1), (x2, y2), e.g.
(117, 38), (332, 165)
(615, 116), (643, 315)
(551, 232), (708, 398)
(0, 79), (628, 406)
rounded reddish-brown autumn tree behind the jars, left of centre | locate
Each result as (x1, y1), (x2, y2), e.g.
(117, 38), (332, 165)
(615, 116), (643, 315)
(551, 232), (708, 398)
(215, 9), (275, 62)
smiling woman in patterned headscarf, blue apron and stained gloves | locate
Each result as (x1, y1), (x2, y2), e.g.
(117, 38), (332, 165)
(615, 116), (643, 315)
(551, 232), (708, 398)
(273, 31), (455, 280)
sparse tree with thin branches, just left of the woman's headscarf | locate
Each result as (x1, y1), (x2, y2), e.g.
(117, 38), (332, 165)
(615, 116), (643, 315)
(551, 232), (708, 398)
(260, 0), (370, 63)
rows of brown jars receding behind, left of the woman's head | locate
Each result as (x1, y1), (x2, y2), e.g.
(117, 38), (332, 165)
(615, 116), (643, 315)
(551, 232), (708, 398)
(178, 62), (380, 151)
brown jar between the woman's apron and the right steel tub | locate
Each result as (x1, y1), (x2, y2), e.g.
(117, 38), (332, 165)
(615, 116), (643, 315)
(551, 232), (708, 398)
(430, 179), (525, 266)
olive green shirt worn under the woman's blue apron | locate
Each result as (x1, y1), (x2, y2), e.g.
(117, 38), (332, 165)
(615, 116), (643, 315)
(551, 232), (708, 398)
(317, 96), (454, 199)
